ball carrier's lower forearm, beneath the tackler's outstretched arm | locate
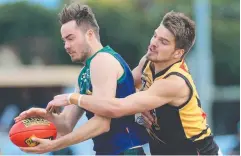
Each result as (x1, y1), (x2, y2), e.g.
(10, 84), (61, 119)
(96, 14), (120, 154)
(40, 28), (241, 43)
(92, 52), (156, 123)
(55, 117), (110, 150)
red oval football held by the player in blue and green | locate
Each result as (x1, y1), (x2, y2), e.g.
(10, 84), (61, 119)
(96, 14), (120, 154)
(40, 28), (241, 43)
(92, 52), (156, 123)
(9, 118), (57, 147)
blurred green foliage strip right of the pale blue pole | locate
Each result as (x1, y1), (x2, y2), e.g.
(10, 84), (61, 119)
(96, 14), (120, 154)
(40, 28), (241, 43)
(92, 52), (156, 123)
(212, 0), (240, 86)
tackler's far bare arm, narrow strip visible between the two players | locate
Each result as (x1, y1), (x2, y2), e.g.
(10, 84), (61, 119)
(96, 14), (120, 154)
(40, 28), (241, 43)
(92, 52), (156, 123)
(132, 55), (146, 88)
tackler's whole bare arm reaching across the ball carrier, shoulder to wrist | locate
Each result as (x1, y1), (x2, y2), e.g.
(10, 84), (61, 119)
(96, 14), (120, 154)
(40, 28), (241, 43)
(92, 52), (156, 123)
(71, 76), (189, 118)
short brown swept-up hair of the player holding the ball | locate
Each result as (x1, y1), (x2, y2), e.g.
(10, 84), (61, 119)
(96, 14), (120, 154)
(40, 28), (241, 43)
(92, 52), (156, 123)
(59, 3), (99, 36)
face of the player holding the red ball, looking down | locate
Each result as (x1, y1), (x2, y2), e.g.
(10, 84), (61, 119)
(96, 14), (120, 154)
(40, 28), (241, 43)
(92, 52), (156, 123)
(60, 20), (90, 63)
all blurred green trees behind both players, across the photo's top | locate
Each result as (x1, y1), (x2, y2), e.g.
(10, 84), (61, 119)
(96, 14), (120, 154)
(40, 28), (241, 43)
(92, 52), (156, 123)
(0, 0), (240, 85)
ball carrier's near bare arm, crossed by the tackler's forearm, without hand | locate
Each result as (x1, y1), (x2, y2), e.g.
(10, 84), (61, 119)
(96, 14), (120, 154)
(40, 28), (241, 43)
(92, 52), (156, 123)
(53, 53), (120, 149)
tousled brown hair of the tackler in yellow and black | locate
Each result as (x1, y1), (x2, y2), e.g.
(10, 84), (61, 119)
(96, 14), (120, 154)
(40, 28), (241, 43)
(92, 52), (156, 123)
(161, 11), (195, 55)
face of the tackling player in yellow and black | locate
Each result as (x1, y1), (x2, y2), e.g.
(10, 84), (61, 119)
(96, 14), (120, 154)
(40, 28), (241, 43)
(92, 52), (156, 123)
(146, 24), (178, 63)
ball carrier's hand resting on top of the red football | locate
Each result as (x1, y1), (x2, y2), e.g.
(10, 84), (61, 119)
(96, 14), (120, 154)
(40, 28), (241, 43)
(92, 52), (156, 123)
(14, 108), (51, 122)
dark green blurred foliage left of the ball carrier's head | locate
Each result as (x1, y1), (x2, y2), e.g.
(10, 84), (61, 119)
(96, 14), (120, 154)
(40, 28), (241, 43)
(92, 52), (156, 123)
(0, 2), (70, 64)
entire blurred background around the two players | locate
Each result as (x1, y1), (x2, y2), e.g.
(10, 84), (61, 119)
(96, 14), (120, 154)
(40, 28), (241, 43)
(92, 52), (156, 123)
(0, 0), (240, 155)
